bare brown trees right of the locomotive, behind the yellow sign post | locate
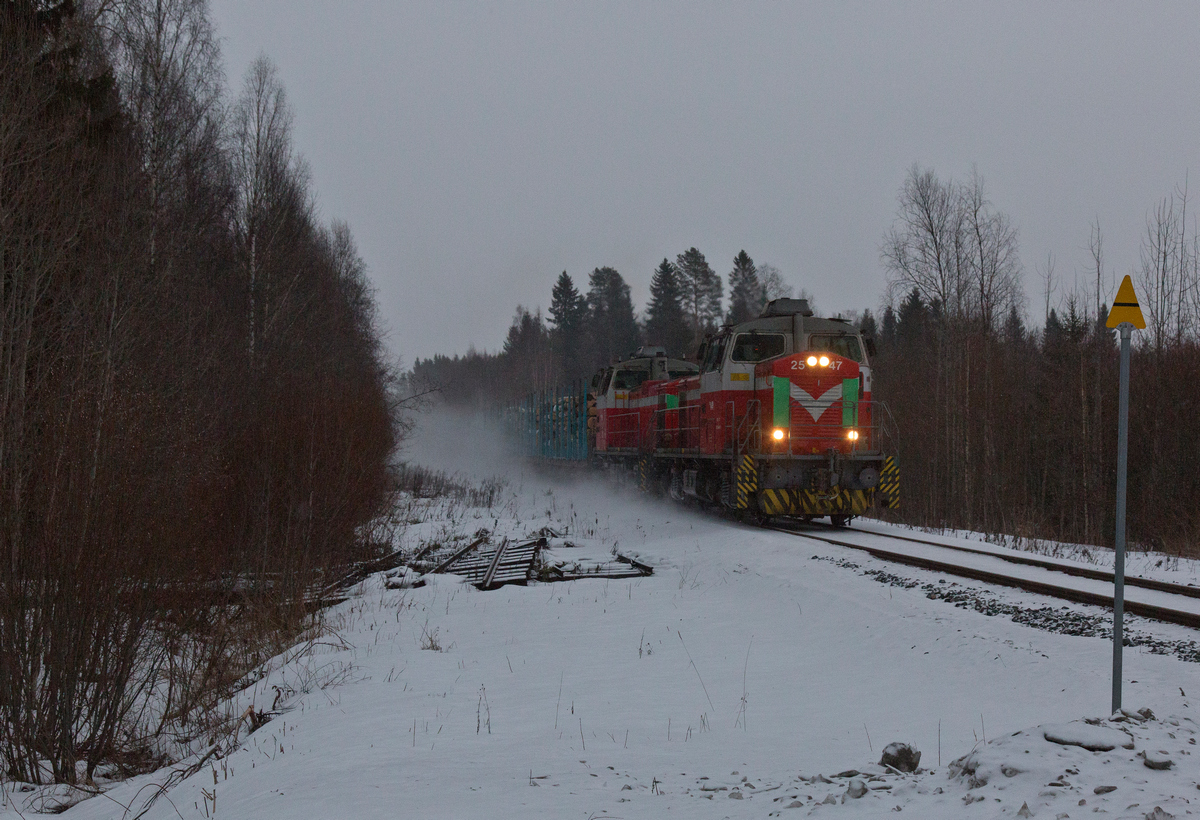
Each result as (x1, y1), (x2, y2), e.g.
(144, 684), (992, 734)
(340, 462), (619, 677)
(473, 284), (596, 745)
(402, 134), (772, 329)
(875, 168), (1200, 555)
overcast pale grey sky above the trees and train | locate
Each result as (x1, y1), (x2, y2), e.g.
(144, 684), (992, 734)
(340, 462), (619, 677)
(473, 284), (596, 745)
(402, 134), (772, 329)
(212, 0), (1200, 364)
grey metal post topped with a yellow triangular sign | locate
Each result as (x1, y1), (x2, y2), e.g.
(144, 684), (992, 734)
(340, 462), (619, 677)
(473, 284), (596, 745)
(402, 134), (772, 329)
(1108, 276), (1146, 712)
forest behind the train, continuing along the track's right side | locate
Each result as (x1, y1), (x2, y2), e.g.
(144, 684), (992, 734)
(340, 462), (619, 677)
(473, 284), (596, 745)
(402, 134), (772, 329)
(413, 167), (1200, 553)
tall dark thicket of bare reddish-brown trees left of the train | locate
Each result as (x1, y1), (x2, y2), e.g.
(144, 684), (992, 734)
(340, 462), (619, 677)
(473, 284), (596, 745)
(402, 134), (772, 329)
(0, 0), (397, 783)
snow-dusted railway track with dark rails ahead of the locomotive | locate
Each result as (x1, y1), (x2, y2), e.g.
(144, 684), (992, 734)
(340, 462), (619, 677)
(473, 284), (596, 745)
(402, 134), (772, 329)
(768, 525), (1200, 629)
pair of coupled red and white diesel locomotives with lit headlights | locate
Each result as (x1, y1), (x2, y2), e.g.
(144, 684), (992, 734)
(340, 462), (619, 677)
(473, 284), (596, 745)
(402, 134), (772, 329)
(588, 299), (900, 525)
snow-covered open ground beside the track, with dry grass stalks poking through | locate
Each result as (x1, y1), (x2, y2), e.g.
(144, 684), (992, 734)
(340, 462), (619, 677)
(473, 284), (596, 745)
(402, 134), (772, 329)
(16, 417), (1200, 820)
